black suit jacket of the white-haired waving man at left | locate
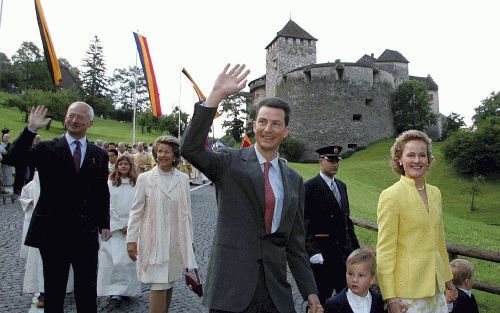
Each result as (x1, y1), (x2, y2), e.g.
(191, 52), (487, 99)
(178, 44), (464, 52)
(9, 129), (109, 250)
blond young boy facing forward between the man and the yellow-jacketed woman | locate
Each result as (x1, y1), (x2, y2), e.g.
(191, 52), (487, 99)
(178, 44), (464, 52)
(325, 248), (384, 313)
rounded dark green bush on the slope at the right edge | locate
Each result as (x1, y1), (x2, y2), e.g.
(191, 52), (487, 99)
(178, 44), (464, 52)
(444, 116), (500, 176)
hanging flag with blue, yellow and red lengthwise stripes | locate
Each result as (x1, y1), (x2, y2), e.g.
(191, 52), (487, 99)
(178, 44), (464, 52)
(134, 32), (161, 116)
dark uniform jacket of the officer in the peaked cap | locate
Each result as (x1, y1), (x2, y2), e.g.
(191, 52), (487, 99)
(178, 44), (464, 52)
(304, 174), (359, 262)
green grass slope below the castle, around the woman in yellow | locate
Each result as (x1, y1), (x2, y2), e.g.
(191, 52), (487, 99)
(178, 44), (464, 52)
(290, 139), (500, 313)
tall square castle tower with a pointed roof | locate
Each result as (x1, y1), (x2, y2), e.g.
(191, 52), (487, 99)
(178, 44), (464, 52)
(266, 19), (318, 97)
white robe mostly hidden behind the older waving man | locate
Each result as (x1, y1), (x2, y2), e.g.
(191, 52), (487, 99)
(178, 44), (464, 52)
(19, 172), (73, 293)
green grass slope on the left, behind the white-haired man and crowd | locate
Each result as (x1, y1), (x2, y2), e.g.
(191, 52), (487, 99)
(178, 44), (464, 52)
(0, 100), (164, 144)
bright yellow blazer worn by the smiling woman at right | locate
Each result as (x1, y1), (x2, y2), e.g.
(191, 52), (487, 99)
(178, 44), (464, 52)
(377, 176), (453, 299)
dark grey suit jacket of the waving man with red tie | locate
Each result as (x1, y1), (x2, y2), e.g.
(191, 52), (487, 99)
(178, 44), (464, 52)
(181, 105), (317, 312)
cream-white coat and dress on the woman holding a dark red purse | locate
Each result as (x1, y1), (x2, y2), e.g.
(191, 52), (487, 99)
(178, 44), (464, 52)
(127, 166), (198, 284)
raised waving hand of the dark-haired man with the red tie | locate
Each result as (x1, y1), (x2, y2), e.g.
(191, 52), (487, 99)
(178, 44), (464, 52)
(205, 63), (250, 108)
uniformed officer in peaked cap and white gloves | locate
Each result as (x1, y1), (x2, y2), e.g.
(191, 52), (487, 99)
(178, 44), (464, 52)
(304, 146), (359, 304)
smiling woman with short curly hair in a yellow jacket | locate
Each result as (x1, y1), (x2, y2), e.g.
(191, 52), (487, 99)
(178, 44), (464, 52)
(377, 130), (456, 313)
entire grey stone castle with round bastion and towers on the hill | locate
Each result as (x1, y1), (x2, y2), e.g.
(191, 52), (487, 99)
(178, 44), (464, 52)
(249, 20), (441, 161)
